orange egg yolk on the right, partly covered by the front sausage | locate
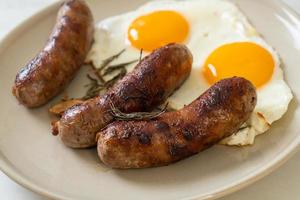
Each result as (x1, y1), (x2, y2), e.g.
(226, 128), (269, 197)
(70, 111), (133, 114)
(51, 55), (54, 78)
(202, 42), (275, 88)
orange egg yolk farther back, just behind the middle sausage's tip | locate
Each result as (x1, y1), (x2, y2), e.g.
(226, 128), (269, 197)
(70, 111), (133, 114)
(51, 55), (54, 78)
(128, 10), (189, 51)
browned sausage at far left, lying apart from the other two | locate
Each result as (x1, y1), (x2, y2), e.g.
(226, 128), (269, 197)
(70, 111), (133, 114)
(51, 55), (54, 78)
(12, 0), (94, 108)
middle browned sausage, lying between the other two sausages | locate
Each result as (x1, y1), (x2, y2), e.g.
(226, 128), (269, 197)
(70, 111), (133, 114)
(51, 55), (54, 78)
(56, 44), (192, 148)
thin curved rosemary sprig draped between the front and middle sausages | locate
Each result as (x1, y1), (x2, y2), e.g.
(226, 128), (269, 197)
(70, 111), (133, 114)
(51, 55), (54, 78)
(110, 102), (168, 121)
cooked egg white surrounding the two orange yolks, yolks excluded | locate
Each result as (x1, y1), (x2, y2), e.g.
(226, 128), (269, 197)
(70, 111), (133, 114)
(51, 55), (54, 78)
(87, 0), (293, 146)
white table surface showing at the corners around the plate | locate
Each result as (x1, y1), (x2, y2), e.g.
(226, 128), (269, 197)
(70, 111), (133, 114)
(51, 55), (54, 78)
(0, 0), (300, 200)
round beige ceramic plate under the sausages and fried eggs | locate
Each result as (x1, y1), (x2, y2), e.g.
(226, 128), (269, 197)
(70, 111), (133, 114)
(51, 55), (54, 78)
(0, 0), (300, 200)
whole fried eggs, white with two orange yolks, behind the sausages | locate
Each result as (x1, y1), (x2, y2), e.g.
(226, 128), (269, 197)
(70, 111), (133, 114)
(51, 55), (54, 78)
(87, 0), (293, 146)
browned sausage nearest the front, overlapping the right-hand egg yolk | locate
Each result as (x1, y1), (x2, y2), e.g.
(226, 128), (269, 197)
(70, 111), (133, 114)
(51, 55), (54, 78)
(97, 78), (256, 168)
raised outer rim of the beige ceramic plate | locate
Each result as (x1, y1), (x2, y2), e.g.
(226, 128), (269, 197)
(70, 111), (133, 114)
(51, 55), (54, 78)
(0, 0), (300, 200)
